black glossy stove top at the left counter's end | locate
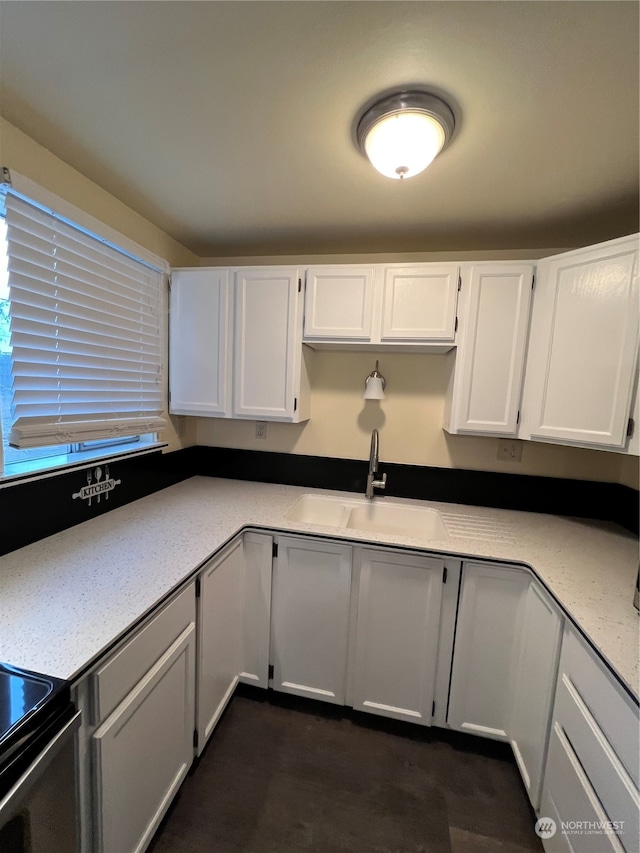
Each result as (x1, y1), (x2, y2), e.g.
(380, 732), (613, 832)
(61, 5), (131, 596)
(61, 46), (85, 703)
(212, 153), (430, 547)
(0, 663), (73, 799)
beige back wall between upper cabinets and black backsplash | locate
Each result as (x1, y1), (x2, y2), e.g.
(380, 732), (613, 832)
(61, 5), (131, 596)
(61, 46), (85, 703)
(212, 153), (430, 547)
(197, 351), (638, 488)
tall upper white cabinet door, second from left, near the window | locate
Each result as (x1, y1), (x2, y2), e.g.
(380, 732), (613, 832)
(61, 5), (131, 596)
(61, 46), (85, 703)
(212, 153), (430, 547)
(233, 267), (309, 422)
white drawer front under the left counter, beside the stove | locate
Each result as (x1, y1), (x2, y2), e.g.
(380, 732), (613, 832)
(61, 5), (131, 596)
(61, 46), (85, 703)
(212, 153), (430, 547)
(91, 584), (196, 725)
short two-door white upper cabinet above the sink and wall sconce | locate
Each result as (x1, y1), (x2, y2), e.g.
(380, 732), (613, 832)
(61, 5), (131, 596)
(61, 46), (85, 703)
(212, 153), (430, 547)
(303, 264), (459, 352)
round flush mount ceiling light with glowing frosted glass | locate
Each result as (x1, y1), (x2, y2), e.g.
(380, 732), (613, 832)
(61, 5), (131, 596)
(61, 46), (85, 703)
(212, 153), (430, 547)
(356, 91), (455, 179)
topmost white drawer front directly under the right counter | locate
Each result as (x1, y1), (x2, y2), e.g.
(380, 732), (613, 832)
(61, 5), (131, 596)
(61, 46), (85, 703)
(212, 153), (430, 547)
(560, 628), (640, 788)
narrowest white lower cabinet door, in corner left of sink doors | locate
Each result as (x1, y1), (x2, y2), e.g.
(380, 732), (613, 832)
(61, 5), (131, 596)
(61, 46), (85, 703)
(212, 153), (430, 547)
(240, 533), (273, 690)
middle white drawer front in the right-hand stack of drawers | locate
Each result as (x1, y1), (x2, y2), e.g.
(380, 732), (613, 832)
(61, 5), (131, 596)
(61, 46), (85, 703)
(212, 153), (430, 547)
(555, 675), (640, 853)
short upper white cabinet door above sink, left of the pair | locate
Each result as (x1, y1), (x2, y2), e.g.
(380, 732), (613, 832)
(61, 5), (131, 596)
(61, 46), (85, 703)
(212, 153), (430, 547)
(304, 266), (375, 341)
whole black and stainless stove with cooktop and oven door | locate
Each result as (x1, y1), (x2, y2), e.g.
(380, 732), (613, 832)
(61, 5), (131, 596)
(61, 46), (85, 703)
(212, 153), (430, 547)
(0, 664), (80, 853)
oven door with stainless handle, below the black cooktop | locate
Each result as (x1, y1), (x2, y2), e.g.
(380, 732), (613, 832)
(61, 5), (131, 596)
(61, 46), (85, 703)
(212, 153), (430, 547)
(0, 709), (80, 853)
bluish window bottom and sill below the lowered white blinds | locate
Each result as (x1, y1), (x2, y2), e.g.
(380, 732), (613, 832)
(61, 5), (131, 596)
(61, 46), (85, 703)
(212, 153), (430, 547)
(0, 441), (168, 489)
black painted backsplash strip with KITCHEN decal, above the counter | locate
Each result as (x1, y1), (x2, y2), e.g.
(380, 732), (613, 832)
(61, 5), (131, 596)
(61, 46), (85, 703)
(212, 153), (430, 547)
(0, 447), (639, 554)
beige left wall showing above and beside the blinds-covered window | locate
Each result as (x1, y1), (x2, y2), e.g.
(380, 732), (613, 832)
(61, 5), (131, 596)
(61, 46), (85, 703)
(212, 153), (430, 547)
(0, 117), (199, 450)
